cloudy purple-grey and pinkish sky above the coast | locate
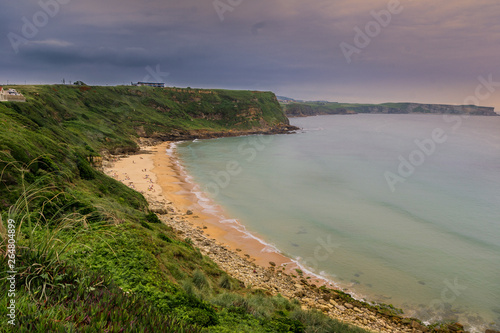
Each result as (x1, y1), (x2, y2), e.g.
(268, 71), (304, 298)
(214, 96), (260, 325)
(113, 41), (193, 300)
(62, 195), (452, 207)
(0, 0), (500, 112)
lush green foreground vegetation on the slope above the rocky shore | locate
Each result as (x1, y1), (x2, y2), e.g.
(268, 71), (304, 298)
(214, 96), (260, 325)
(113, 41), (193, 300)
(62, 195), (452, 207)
(0, 185), (376, 332)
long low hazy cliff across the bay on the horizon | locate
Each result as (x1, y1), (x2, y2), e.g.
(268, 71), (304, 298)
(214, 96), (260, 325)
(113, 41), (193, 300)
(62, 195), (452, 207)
(283, 102), (498, 117)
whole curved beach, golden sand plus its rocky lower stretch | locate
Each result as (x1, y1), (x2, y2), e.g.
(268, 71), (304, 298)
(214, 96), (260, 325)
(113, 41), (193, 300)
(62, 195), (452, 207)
(104, 141), (464, 333)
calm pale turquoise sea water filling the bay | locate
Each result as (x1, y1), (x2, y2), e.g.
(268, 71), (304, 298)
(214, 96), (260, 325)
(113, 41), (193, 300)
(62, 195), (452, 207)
(177, 115), (500, 330)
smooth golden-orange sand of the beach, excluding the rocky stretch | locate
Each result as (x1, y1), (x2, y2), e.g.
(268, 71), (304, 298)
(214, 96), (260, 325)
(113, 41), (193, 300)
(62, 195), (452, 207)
(105, 142), (337, 287)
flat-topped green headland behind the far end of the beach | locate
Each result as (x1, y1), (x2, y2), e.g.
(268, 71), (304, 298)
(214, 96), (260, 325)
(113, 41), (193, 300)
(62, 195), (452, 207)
(0, 85), (291, 153)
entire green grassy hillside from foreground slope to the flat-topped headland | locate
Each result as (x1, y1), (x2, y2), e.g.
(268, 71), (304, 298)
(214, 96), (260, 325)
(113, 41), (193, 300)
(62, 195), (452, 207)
(0, 86), (363, 332)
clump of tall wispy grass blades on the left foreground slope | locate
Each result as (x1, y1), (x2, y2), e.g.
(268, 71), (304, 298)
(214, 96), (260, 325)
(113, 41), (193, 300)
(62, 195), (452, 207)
(0, 160), (101, 299)
